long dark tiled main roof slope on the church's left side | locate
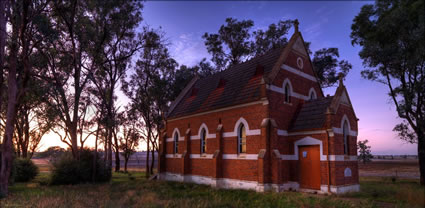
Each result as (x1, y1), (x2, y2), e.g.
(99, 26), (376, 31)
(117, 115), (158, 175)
(167, 47), (284, 118)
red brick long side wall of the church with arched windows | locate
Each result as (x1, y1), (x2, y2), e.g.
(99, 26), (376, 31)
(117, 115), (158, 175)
(165, 103), (267, 181)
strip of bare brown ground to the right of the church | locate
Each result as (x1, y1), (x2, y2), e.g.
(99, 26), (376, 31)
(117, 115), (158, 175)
(359, 160), (420, 179)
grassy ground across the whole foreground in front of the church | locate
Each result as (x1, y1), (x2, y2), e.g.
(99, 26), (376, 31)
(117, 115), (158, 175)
(0, 160), (425, 208)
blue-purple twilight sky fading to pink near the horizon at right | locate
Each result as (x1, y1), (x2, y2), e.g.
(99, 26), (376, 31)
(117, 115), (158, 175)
(41, 1), (417, 154)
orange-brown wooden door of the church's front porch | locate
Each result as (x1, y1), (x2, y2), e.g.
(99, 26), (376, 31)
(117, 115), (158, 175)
(298, 145), (320, 190)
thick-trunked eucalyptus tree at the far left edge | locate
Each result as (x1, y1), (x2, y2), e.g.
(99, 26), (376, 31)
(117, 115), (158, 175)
(0, 0), (47, 196)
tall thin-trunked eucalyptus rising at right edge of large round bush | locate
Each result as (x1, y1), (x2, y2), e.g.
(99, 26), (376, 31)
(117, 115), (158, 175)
(90, 0), (143, 171)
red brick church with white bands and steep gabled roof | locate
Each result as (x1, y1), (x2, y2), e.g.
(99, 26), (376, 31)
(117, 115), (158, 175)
(159, 23), (360, 194)
